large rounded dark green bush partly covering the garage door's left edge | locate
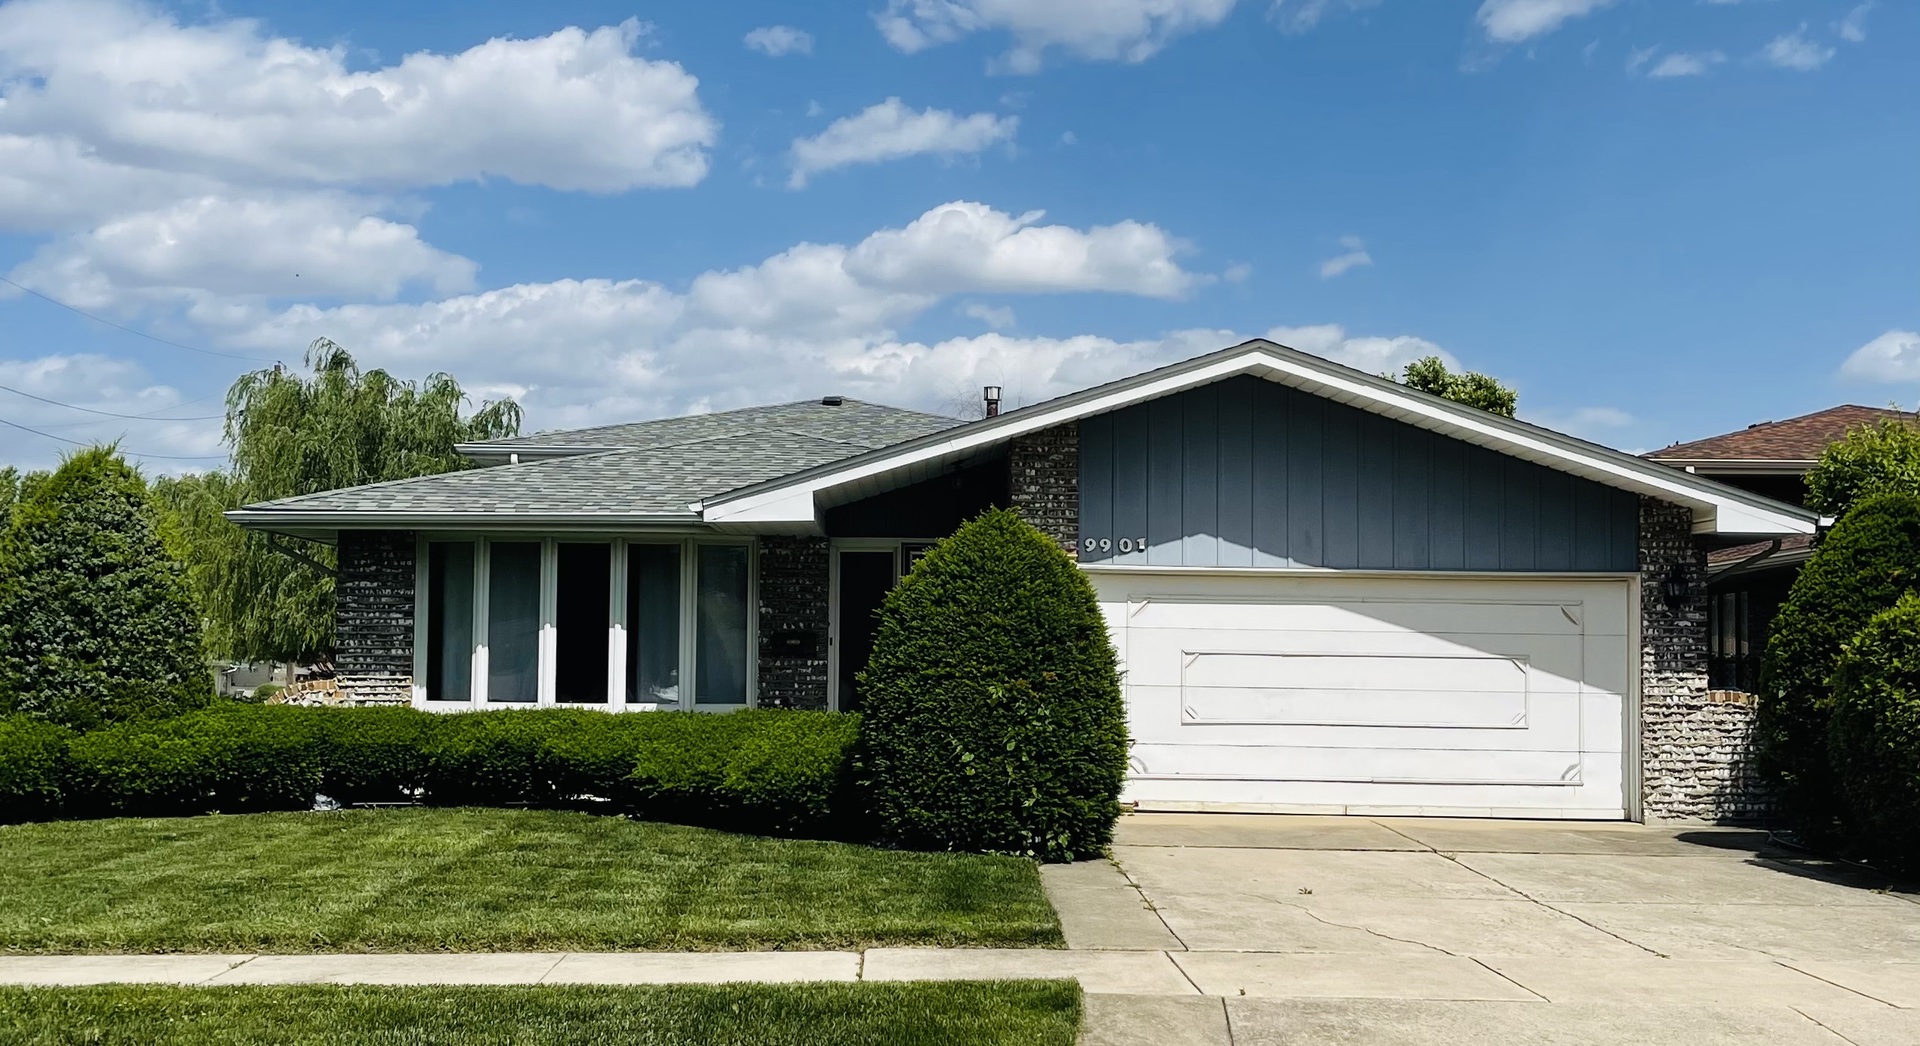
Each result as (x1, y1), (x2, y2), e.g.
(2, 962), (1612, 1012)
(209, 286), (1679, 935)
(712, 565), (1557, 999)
(858, 509), (1127, 860)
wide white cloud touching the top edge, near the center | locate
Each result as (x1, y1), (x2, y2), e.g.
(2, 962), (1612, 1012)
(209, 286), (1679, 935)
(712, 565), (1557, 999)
(874, 0), (1235, 73)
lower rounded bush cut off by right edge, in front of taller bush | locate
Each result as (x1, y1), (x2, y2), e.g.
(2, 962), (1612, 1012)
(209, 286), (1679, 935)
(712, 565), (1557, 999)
(1828, 595), (1920, 871)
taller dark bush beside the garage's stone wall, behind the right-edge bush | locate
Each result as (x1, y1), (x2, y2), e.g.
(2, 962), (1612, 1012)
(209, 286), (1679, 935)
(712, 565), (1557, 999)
(1759, 493), (1920, 844)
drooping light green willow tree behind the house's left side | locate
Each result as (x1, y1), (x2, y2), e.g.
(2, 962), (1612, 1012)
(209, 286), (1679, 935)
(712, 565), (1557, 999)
(156, 338), (520, 664)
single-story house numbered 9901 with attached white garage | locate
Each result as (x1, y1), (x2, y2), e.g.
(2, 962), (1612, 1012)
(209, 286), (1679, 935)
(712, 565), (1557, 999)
(230, 340), (1818, 820)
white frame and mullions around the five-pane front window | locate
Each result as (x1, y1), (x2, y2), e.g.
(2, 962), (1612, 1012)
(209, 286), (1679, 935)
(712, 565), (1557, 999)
(413, 532), (760, 712)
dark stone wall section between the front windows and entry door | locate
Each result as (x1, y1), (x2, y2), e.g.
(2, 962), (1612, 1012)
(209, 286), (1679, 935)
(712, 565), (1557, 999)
(758, 537), (829, 708)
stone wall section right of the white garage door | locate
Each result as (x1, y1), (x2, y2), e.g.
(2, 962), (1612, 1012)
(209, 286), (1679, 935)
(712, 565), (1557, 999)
(1640, 497), (1772, 821)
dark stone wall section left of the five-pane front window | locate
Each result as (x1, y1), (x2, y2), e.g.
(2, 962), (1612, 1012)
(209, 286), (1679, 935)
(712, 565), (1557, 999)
(334, 530), (413, 695)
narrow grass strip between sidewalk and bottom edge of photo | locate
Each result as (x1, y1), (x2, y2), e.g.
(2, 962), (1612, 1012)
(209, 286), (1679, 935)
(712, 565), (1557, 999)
(0, 981), (1081, 1046)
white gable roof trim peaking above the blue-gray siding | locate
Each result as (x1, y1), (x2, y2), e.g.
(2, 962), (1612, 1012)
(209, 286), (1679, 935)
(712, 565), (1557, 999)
(701, 342), (1818, 535)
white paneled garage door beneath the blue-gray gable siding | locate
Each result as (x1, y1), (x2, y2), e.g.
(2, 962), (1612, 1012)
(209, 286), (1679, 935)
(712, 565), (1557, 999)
(1091, 572), (1634, 820)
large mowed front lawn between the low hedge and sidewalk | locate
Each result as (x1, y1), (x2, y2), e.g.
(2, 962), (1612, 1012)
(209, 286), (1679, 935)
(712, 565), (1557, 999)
(0, 808), (1062, 952)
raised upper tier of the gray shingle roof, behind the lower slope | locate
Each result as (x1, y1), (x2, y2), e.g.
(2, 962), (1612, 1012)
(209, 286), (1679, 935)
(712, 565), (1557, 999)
(470, 399), (960, 451)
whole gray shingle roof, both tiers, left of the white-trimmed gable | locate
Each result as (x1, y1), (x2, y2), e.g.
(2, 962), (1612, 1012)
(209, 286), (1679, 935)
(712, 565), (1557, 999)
(234, 399), (960, 520)
